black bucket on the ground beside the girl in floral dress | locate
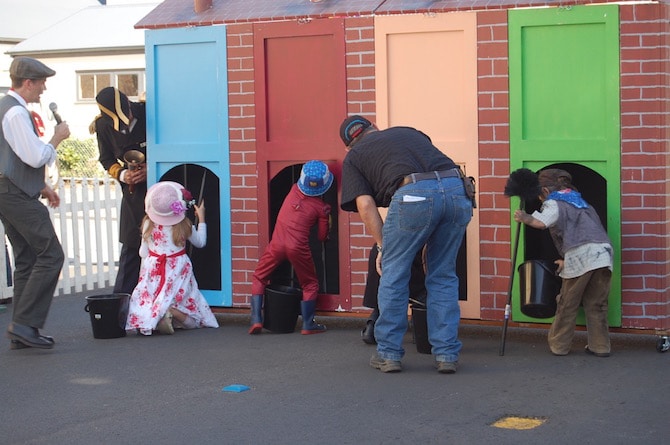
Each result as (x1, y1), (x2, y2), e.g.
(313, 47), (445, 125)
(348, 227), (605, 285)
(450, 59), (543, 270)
(84, 294), (130, 338)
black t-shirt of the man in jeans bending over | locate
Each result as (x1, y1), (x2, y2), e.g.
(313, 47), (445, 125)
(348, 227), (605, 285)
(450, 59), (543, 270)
(340, 127), (457, 212)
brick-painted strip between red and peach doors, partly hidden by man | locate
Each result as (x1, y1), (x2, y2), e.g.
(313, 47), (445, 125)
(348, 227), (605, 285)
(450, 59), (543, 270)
(345, 17), (376, 311)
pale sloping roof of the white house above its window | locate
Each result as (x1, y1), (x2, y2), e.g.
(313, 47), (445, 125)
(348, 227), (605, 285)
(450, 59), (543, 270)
(8, 2), (158, 56)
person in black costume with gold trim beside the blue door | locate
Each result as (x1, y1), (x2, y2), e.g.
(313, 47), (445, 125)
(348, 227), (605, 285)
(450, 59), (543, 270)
(90, 87), (147, 294)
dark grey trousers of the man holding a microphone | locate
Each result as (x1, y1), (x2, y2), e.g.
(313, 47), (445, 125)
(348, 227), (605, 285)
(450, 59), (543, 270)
(0, 178), (64, 329)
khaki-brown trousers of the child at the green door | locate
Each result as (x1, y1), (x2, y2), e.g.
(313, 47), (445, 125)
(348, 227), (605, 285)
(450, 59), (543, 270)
(548, 267), (612, 355)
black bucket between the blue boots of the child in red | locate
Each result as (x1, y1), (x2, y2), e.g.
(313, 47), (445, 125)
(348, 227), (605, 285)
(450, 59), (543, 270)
(263, 284), (302, 334)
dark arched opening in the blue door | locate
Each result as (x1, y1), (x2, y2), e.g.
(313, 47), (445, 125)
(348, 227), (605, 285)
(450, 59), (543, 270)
(160, 164), (221, 290)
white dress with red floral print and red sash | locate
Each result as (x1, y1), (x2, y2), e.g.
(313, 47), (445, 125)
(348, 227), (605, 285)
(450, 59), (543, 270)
(126, 223), (219, 334)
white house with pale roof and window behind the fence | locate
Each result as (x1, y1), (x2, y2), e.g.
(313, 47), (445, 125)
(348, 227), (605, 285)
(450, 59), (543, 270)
(0, 0), (159, 139)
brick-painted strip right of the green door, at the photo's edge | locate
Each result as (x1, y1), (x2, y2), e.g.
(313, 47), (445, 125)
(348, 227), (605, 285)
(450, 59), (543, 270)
(620, 4), (670, 329)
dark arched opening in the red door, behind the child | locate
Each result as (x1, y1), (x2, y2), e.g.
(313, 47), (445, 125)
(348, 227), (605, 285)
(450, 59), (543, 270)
(269, 164), (340, 294)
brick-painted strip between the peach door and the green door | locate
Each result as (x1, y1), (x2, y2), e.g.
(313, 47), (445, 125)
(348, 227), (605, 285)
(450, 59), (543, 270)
(477, 10), (511, 320)
